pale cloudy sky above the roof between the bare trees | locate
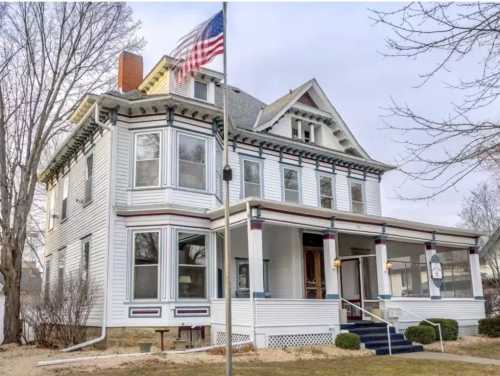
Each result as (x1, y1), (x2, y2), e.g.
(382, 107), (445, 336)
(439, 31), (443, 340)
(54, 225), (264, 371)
(130, 2), (487, 226)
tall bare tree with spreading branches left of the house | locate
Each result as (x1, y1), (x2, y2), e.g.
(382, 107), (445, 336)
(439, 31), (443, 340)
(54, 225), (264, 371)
(0, 3), (143, 343)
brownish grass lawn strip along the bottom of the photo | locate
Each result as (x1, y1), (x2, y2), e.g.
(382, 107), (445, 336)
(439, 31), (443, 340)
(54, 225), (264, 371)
(57, 357), (500, 376)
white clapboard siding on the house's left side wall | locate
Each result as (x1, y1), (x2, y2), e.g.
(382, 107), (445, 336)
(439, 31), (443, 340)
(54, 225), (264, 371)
(45, 132), (110, 325)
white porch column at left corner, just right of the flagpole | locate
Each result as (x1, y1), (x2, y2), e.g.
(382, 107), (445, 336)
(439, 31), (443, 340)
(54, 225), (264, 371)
(248, 218), (265, 298)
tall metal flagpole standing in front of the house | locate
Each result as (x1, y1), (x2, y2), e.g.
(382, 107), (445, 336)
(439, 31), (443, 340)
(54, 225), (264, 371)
(222, 1), (233, 376)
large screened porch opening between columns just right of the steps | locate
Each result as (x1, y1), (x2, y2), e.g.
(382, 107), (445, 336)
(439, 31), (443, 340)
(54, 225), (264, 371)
(387, 241), (429, 297)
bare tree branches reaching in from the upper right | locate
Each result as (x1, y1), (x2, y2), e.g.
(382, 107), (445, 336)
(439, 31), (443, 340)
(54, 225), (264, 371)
(372, 2), (500, 199)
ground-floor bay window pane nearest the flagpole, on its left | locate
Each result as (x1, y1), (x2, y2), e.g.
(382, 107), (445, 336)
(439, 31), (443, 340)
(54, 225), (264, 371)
(178, 232), (207, 299)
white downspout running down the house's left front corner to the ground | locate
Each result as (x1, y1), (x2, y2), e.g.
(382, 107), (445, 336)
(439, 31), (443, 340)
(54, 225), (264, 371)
(61, 102), (115, 352)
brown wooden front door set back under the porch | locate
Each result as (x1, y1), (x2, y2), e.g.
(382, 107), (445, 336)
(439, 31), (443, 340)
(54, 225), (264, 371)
(304, 247), (325, 299)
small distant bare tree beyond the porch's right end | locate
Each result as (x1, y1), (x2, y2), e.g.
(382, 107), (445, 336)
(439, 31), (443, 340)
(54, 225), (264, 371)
(460, 182), (500, 287)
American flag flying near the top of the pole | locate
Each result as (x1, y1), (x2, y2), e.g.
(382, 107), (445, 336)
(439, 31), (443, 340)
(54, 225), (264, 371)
(171, 11), (224, 82)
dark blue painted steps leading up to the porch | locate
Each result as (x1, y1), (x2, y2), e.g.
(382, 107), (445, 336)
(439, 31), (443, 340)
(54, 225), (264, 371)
(340, 321), (424, 355)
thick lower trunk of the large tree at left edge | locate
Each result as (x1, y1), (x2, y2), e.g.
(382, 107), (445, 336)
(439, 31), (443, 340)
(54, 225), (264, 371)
(3, 245), (22, 344)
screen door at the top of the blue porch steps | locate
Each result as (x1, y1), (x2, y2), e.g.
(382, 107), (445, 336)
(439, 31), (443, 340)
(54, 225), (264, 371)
(340, 258), (363, 321)
